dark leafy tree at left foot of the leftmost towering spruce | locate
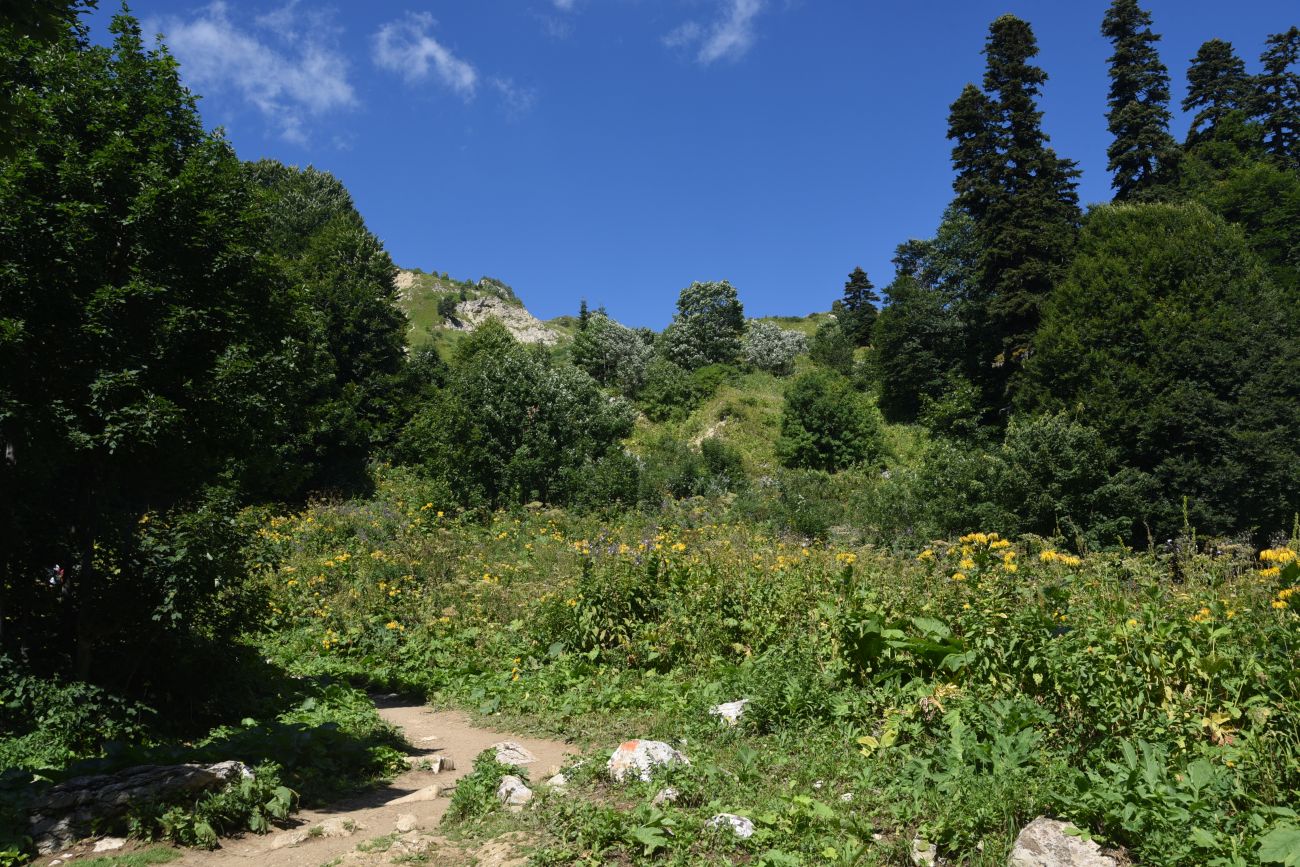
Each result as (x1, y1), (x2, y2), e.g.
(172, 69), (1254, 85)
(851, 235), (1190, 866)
(871, 276), (963, 421)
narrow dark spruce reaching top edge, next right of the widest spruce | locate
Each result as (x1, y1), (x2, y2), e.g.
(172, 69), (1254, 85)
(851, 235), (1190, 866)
(1101, 0), (1175, 200)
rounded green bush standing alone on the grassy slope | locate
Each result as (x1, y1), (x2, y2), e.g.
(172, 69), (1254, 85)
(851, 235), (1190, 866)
(776, 370), (883, 472)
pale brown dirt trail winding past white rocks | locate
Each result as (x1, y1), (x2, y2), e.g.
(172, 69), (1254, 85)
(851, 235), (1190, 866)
(170, 699), (576, 867)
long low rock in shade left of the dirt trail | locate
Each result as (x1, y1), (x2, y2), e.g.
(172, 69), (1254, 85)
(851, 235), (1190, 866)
(27, 762), (252, 855)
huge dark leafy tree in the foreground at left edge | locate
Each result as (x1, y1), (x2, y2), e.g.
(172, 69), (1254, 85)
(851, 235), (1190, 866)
(0, 16), (328, 676)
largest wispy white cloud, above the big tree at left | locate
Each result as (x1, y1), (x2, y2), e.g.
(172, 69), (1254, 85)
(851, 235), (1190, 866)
(148, 0), (356, 143)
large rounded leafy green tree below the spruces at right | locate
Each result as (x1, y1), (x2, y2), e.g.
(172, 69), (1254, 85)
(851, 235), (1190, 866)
(1026, 204), (1300, 534)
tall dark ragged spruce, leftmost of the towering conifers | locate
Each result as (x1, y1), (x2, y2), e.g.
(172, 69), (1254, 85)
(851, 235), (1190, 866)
(948, 14), (1079, 408)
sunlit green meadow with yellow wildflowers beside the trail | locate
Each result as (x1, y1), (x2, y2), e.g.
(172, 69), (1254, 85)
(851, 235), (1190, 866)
(241, 471), (1300, 864)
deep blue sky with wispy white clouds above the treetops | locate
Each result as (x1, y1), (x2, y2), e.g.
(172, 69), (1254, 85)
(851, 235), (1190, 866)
(91, 0), (1300, 328)
